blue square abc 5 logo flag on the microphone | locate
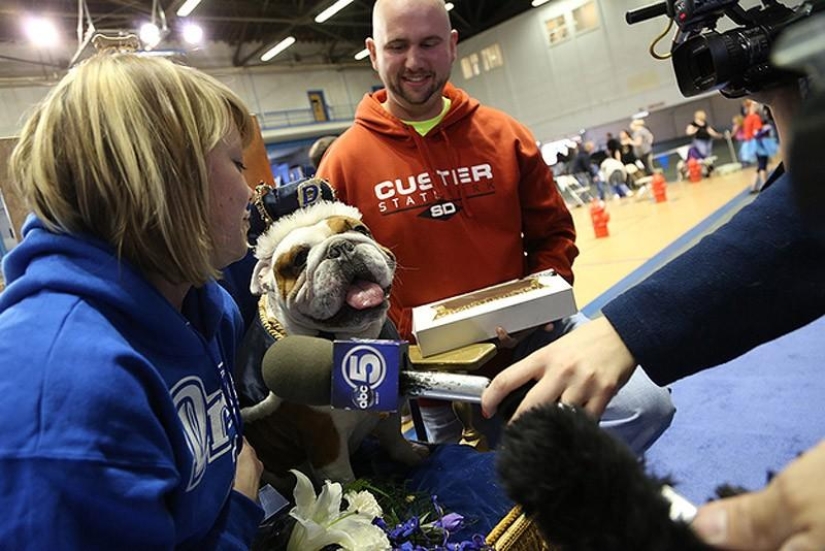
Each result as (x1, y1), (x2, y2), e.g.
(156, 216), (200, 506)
(331, 339), (409, 411)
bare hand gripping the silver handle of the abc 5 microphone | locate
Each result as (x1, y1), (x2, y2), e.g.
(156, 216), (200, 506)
(481, 317), (636, 419)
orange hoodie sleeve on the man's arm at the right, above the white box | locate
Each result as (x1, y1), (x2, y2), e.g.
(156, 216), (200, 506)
(516, 123), (579, 283)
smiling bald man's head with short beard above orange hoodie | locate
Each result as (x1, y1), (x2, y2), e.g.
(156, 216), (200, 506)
(367, 0), (458, 120)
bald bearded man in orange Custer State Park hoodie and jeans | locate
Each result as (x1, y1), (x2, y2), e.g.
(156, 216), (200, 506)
(318, 0), (674, 453)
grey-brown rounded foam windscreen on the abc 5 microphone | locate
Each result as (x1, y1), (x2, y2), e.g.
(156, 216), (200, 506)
(261, 335), (332, 406)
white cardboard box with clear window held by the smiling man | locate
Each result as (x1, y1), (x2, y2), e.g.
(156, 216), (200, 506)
(412, 270), (577, 357)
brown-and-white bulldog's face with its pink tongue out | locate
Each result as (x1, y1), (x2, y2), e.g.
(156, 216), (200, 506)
(251, 202), (395, 338)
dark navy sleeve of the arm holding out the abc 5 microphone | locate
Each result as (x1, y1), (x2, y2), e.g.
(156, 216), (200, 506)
(602, 177), (825, 384)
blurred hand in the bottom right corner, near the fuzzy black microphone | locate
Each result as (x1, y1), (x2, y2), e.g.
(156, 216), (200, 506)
(692, 440), (825, 551)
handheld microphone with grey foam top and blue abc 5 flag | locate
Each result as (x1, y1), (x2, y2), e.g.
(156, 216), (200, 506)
(262, 335), (526, 419)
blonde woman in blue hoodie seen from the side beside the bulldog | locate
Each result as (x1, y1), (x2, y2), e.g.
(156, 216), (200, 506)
(0, 54), (262, 549)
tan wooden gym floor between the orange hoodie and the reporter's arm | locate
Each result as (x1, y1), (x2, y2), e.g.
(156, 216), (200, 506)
(571, 167), (756, 317)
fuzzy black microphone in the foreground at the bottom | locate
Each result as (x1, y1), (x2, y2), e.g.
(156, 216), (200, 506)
(496, 404), (711, 551)
